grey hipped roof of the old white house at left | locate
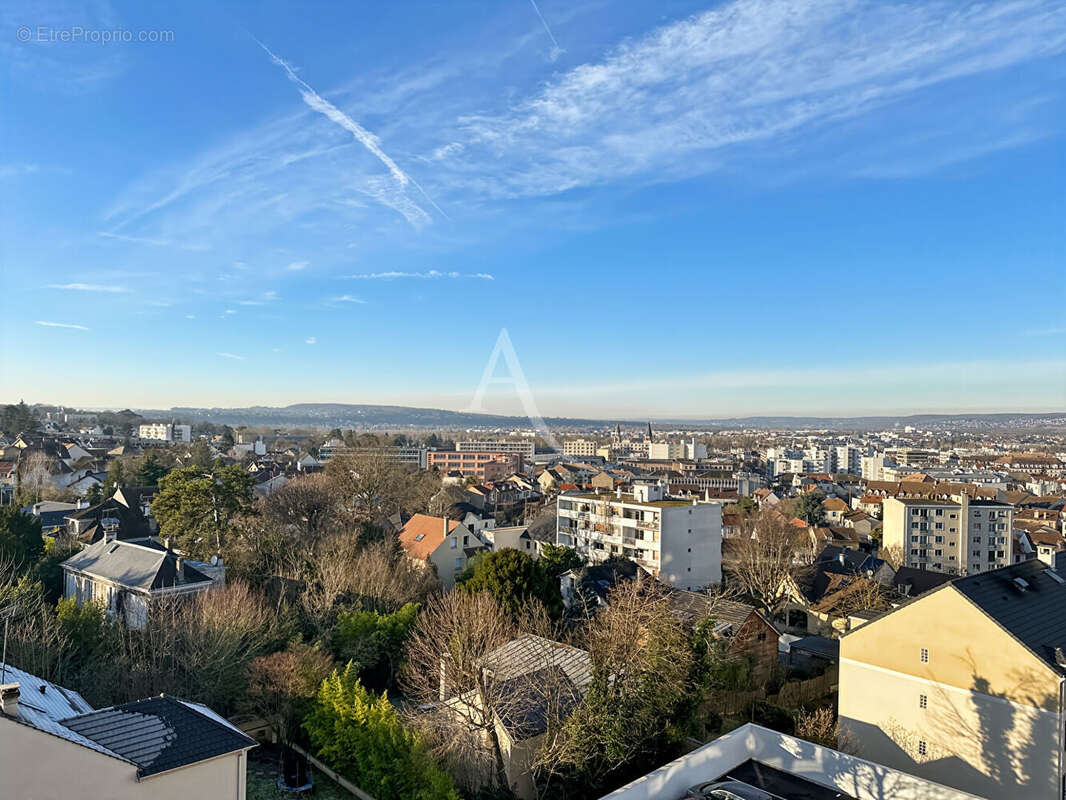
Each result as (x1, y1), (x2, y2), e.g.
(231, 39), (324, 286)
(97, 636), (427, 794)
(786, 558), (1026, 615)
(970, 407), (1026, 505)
(63, 540), (211, 591)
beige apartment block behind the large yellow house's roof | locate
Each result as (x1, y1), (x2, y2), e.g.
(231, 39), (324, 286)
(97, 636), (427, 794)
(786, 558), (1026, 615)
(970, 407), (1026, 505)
(882, 493), (1014, 575)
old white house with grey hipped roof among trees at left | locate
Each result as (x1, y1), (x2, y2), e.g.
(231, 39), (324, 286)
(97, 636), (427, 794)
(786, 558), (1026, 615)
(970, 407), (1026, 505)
(62, 539), (226, 630)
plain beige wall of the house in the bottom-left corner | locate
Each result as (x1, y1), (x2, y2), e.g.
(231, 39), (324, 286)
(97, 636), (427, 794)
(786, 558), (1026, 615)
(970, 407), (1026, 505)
(0, 719), (247, 800)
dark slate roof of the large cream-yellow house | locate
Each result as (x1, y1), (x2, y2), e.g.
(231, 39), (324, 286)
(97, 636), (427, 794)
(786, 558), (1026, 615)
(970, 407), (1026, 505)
(952, 559), (1066, 674)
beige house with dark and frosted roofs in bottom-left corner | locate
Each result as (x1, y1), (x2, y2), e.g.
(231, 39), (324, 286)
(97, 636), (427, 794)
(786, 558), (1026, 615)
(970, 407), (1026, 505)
(0, 665), (256, 800)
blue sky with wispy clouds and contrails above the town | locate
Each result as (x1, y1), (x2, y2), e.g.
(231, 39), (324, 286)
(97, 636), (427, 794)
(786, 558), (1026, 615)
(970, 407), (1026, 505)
(0, 0), (1066, 417)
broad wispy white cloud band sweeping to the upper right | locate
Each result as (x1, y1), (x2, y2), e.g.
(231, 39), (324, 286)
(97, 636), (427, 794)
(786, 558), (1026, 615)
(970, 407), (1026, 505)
(456, 0), (1066, 196)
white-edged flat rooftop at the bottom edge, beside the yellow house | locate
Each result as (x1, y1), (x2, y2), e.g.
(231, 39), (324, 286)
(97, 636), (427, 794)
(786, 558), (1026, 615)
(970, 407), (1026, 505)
(600, 722), (980, 800)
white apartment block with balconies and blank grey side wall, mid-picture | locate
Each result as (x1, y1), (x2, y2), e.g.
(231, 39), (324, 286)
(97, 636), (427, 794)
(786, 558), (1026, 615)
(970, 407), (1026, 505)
(555, 484), (722, 589)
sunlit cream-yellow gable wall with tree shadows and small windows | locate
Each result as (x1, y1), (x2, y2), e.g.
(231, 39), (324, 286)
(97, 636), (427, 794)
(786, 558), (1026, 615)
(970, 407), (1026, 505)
(839, 586), (1062, 798)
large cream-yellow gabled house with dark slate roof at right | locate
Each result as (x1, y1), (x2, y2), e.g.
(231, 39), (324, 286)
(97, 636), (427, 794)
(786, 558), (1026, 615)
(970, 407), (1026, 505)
(839, 559), (1066, 800)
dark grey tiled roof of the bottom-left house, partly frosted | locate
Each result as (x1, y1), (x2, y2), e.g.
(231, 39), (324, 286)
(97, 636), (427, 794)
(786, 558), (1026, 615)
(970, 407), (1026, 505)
(62, 695), (256, 778)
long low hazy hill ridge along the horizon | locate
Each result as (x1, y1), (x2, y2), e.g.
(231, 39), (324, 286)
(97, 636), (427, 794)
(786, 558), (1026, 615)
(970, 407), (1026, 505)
(126, 403), (1066, 431)
